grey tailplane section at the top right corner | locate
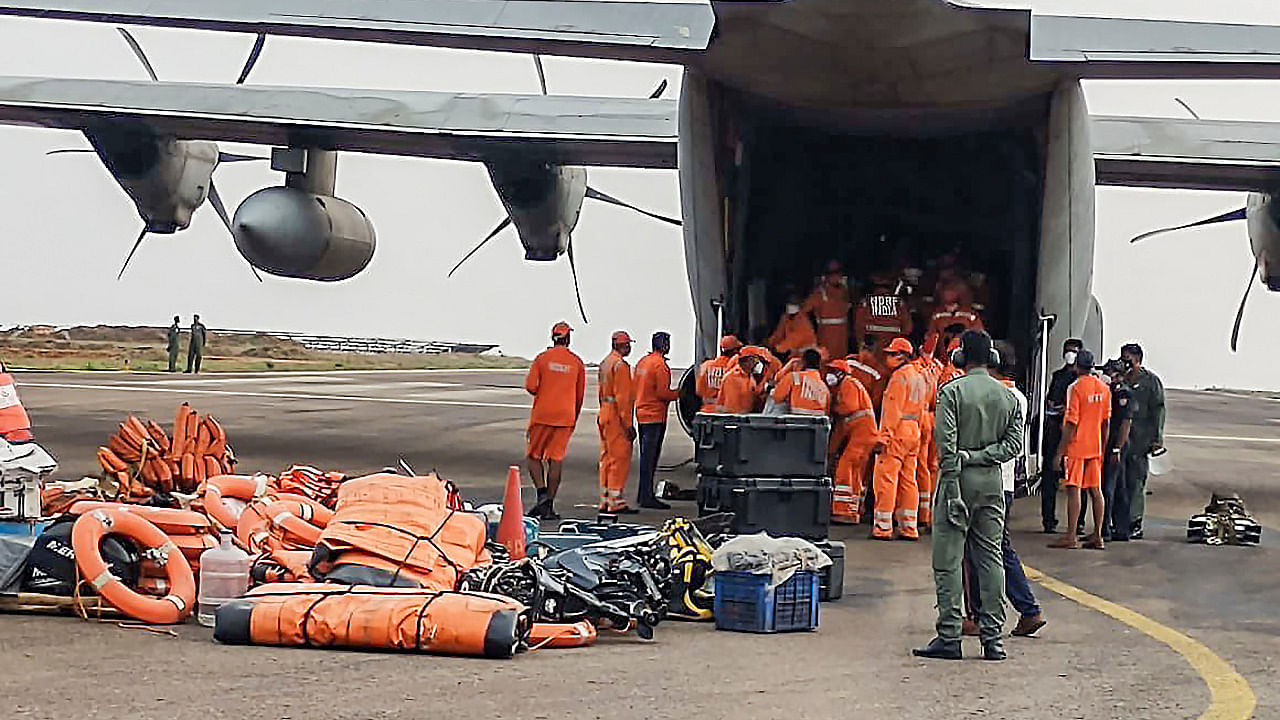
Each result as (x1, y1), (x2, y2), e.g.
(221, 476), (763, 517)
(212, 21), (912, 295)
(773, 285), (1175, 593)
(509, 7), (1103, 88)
(1028, 13), (1280, 79)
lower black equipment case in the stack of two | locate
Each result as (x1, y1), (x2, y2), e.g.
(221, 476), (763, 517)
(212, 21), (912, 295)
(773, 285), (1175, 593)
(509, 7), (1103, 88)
(698, 475), (831, 541)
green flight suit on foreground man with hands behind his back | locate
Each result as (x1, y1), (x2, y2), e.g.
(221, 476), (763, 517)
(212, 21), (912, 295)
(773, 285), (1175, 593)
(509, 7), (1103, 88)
(933, 368), (1023, 643)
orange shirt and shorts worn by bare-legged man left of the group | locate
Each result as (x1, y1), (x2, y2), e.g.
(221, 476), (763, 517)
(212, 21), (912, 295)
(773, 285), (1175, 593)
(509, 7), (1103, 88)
(525, 345), (586, 462)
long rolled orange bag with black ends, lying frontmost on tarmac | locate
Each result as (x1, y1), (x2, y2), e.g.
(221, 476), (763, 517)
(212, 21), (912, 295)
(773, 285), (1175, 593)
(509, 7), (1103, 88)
(214, 583), (530, 659)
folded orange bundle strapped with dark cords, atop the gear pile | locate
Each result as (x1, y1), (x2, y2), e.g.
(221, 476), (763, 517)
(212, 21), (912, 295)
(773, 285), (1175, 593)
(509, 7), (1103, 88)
(311, 473), (492, 591)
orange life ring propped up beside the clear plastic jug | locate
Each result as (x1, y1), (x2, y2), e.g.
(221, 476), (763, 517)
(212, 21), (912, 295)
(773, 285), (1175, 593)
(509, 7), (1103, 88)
(72, 509), (196, 624)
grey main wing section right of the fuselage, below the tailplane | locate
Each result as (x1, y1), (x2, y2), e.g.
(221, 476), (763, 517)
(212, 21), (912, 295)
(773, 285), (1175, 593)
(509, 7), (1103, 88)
(1089, 115), (1280, 191)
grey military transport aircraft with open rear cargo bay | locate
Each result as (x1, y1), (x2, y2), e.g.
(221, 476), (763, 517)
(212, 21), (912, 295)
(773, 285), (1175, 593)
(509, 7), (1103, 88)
(0, 0), (1280, 366)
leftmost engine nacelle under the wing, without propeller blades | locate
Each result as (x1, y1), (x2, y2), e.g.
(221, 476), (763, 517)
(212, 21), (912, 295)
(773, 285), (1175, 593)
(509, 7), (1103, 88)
(84, 126), (218, 233)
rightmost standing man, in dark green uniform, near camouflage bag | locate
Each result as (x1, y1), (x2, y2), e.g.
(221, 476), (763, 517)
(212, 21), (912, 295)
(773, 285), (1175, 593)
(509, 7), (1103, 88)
(1120, 343), (1165, 539)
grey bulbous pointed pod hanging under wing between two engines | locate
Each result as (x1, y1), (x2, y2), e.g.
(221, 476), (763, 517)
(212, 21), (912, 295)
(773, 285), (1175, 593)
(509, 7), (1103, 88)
(232, 187), (376, 282)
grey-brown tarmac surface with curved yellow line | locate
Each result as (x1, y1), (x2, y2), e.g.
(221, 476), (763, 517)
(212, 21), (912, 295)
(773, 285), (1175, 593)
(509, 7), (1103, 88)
(0, 372), (1280, 720)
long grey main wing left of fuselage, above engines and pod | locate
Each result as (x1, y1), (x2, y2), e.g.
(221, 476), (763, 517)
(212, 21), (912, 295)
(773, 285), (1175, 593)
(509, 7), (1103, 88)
(0, 77), (677, 168)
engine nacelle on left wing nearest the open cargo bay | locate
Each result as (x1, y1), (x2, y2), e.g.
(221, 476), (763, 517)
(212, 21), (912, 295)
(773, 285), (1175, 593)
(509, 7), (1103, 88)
(485, 159), (586, 261)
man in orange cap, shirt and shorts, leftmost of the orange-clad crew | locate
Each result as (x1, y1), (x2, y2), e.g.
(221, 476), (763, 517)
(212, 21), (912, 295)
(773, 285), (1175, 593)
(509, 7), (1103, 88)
(525, 323), (586, 520)
